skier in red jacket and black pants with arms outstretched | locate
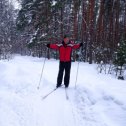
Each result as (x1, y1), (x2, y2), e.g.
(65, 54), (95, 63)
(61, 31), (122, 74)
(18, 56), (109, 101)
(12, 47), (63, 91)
(47, 35), (83, 88)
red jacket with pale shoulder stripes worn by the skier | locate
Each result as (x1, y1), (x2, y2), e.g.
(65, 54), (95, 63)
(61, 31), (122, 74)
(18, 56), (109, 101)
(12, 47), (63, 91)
(50, 42), (80, 62)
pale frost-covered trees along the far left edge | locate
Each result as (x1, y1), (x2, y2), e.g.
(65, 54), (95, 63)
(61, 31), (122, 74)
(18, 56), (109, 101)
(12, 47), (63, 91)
(0, 0), (16, 59)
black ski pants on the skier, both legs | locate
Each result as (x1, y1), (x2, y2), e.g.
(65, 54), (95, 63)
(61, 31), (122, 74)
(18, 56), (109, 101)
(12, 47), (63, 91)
(57, 61), (71, 87)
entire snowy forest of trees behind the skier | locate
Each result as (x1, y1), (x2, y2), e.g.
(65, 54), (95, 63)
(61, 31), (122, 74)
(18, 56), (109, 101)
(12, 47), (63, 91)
(0, 0), (126, 79)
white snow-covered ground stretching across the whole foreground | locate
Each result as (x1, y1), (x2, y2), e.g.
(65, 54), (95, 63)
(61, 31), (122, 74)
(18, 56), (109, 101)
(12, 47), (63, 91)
(0, 56), (126, 126)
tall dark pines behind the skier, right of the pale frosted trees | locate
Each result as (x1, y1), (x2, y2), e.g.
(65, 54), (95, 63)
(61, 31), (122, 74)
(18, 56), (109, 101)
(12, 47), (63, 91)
(17, 0), (126, 63)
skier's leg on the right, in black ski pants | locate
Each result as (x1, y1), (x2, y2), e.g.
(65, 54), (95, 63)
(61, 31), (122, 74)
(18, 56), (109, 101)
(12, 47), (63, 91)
(64, 62), (71, 87)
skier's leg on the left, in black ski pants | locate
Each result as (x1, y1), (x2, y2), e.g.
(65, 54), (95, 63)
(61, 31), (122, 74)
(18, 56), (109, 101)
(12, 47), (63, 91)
(57, 62), (64, 87)
